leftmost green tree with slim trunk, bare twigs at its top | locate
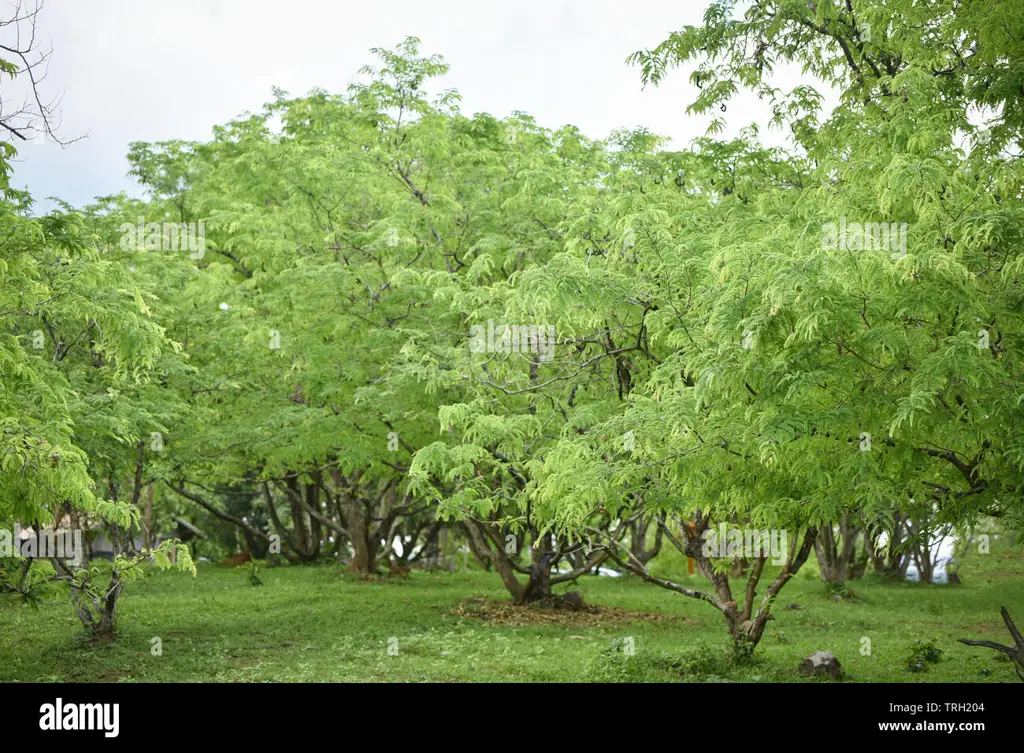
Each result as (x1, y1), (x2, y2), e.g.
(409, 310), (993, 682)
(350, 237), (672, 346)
(0, 2), (195, 640)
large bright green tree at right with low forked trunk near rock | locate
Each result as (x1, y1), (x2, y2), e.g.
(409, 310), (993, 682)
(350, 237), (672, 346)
(540, 1), (1021, 645)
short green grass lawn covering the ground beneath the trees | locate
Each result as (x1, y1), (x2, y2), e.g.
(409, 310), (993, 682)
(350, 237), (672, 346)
(0, 542), (1024, 682)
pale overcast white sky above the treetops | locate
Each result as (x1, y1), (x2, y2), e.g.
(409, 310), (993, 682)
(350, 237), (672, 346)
(4, 0), (796, 209)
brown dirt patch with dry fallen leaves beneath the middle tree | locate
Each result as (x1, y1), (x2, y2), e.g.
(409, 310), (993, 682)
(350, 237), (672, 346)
(450, 598), (692, 627)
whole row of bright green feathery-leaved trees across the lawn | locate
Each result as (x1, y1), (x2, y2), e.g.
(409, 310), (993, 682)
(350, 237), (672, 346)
(0, 0), (1024, 652)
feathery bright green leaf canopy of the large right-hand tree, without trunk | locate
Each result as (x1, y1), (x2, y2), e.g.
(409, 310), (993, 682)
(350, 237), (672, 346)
(614, 2), (1024, 522)
